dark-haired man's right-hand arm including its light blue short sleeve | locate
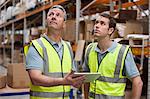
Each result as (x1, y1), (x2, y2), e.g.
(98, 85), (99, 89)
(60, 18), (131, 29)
(125, 50), (143, 99)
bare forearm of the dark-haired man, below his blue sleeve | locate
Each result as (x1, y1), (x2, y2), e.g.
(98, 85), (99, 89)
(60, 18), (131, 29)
(131, 76), (143, 99)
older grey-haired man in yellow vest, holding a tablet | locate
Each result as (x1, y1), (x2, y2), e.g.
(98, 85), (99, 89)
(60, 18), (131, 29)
(25, 5), (84, 99)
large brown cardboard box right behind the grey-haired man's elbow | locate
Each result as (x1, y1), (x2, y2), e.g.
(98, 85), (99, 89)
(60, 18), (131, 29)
(7, 63), (30, 88)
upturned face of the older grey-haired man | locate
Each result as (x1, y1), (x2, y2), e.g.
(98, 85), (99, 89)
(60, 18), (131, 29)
(47, 8), (64, 30)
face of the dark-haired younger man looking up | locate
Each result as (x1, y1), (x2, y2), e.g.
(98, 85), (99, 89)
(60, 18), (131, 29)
(94, 16), (110, 37)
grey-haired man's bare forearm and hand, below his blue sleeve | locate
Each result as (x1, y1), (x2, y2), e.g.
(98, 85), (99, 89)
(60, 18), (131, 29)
(28, 70), (84, 88)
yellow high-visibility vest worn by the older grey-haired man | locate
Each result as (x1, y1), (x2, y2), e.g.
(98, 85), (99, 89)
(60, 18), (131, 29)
(30, 37), (72, 99)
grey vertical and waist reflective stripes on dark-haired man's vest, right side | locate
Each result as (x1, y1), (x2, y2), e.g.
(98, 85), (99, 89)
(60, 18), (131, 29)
(97, 46), (126, 83)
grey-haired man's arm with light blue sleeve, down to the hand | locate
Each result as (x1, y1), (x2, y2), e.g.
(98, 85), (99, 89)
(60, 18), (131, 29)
(26, 46), (83, 87)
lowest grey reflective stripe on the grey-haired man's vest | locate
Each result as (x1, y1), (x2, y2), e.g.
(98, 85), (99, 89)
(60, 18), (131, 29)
(30, 91), (70, 98)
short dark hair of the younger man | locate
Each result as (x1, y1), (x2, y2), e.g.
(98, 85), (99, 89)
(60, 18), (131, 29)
(100, 12), (116, 30)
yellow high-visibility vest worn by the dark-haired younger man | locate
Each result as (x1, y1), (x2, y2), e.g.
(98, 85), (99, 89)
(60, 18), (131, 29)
(88, 43), (129, 96)
